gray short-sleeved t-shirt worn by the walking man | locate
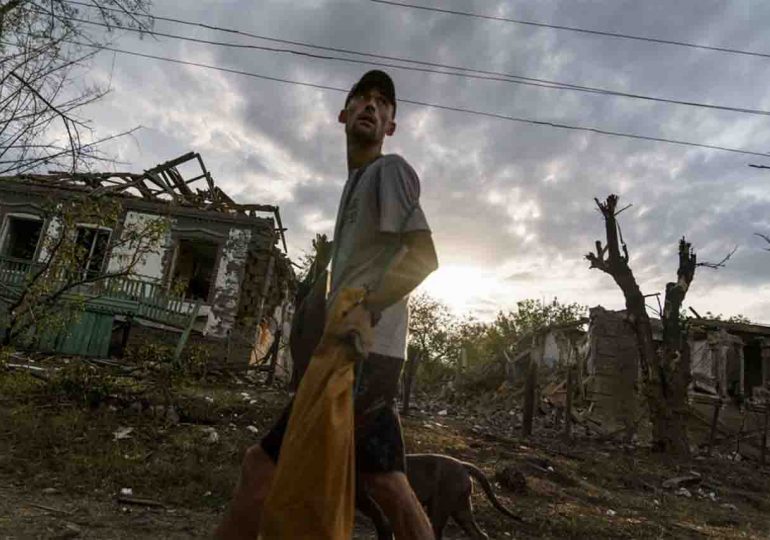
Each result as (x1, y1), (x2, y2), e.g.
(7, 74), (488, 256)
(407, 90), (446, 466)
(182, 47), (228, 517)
(329, 154), (430, 358)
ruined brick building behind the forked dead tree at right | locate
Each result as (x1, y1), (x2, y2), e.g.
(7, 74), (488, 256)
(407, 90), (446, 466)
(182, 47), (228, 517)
(507, 306), (770, 442)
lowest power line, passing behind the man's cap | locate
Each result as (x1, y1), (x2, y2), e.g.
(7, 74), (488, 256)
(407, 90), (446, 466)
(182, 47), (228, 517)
(58, 41), (770, 157)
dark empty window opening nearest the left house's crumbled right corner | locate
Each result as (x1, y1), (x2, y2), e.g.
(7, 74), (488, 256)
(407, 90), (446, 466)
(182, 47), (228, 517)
(171, 239), (219, 302)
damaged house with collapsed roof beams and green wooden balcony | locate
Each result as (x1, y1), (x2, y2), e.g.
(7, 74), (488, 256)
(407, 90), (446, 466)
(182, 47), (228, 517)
(0, 152), (295, 365)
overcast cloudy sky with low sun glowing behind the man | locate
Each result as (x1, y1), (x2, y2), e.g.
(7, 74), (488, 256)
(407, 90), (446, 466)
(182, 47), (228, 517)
(75, 0), (770, 323)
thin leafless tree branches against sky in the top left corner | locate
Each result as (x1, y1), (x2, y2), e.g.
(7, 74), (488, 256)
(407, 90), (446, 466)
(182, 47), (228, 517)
(0, 0), (151, 174)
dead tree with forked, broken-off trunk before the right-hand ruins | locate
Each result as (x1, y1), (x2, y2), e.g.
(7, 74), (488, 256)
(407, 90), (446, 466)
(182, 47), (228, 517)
(586, 195), (699, 456)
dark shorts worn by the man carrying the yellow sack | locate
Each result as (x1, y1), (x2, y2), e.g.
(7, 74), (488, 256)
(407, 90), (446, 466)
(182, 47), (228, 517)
(261, 354), (406, 473)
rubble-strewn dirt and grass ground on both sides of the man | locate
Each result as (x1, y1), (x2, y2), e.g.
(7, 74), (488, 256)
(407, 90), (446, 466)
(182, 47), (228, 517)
(0, 360), (770, 539)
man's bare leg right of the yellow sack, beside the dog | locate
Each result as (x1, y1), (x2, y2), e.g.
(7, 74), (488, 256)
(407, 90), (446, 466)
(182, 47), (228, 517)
(363, 472), (435, 540)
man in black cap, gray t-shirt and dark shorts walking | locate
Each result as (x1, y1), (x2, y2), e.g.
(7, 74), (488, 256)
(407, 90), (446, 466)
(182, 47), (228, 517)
(217, 70), (438, 540)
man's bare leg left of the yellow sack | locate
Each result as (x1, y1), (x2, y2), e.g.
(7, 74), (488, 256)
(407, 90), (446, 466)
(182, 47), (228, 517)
(214, 444), (275, 540)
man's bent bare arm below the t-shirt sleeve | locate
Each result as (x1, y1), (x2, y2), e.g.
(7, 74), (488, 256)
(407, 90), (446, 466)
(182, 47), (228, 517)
(364, 231), (438, 317)
